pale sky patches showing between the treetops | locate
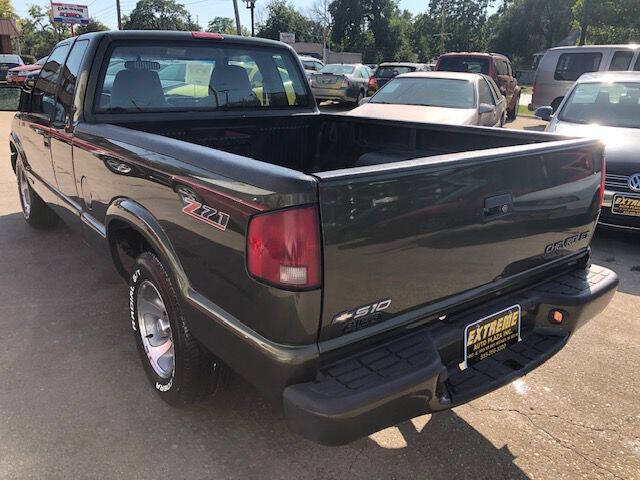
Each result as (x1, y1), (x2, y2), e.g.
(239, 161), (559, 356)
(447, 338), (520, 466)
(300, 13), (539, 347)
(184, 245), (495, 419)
(12, 0), (440, 32)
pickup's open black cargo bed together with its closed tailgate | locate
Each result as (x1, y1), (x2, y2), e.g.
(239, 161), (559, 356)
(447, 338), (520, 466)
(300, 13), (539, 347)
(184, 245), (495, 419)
(112, 115), (602, 349)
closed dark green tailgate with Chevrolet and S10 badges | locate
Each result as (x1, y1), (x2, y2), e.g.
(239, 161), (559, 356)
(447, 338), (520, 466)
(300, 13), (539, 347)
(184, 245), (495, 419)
(317, 140), (602, 340)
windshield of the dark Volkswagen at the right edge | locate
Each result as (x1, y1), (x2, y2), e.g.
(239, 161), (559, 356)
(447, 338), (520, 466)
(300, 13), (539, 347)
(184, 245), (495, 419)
(558, 82), (640, 128)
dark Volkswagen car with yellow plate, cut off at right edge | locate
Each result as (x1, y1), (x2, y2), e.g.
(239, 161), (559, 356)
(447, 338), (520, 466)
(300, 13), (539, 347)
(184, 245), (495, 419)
(536, 72), (640, 231)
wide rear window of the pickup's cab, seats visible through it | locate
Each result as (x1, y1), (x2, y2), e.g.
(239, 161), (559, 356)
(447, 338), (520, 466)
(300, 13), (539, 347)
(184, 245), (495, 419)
(95, 44), (310, 113)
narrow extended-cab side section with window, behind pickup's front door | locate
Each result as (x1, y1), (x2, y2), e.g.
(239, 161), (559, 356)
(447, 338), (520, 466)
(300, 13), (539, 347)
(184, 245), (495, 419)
(50, 40), (89, 223)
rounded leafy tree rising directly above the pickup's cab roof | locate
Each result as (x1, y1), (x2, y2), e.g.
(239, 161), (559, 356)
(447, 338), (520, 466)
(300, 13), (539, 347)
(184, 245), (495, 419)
(122, 0), (200, 31)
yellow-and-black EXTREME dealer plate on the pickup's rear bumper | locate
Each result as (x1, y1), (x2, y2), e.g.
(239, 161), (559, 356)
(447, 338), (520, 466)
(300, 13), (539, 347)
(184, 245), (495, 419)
(462, 305), (521, 369)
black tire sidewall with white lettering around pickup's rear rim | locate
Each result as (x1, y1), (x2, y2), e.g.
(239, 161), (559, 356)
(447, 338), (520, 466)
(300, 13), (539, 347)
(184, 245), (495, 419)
(129, 253), (184, 404)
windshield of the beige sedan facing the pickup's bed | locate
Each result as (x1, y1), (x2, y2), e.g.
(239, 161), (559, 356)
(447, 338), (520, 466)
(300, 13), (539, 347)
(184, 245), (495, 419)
(370, 77), (476, 108)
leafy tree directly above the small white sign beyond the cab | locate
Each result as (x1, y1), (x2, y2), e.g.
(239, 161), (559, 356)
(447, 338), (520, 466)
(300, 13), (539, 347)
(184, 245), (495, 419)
(256, 0), (322, 42)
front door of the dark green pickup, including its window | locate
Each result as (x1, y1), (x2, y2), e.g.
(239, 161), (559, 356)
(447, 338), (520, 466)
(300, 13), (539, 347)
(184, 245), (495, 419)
(22, 41), (71, 191)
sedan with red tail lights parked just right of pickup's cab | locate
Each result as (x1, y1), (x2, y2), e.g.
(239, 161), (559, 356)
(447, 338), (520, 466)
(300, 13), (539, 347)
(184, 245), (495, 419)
(309, 63), (370, 105)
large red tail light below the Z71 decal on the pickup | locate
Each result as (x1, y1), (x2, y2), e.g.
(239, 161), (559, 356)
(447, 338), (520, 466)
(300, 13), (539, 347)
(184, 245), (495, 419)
(247, 206), (321, 290)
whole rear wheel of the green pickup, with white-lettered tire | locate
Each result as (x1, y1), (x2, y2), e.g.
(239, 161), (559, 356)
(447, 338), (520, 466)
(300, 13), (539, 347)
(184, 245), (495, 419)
(129, 252), (228, 407)
